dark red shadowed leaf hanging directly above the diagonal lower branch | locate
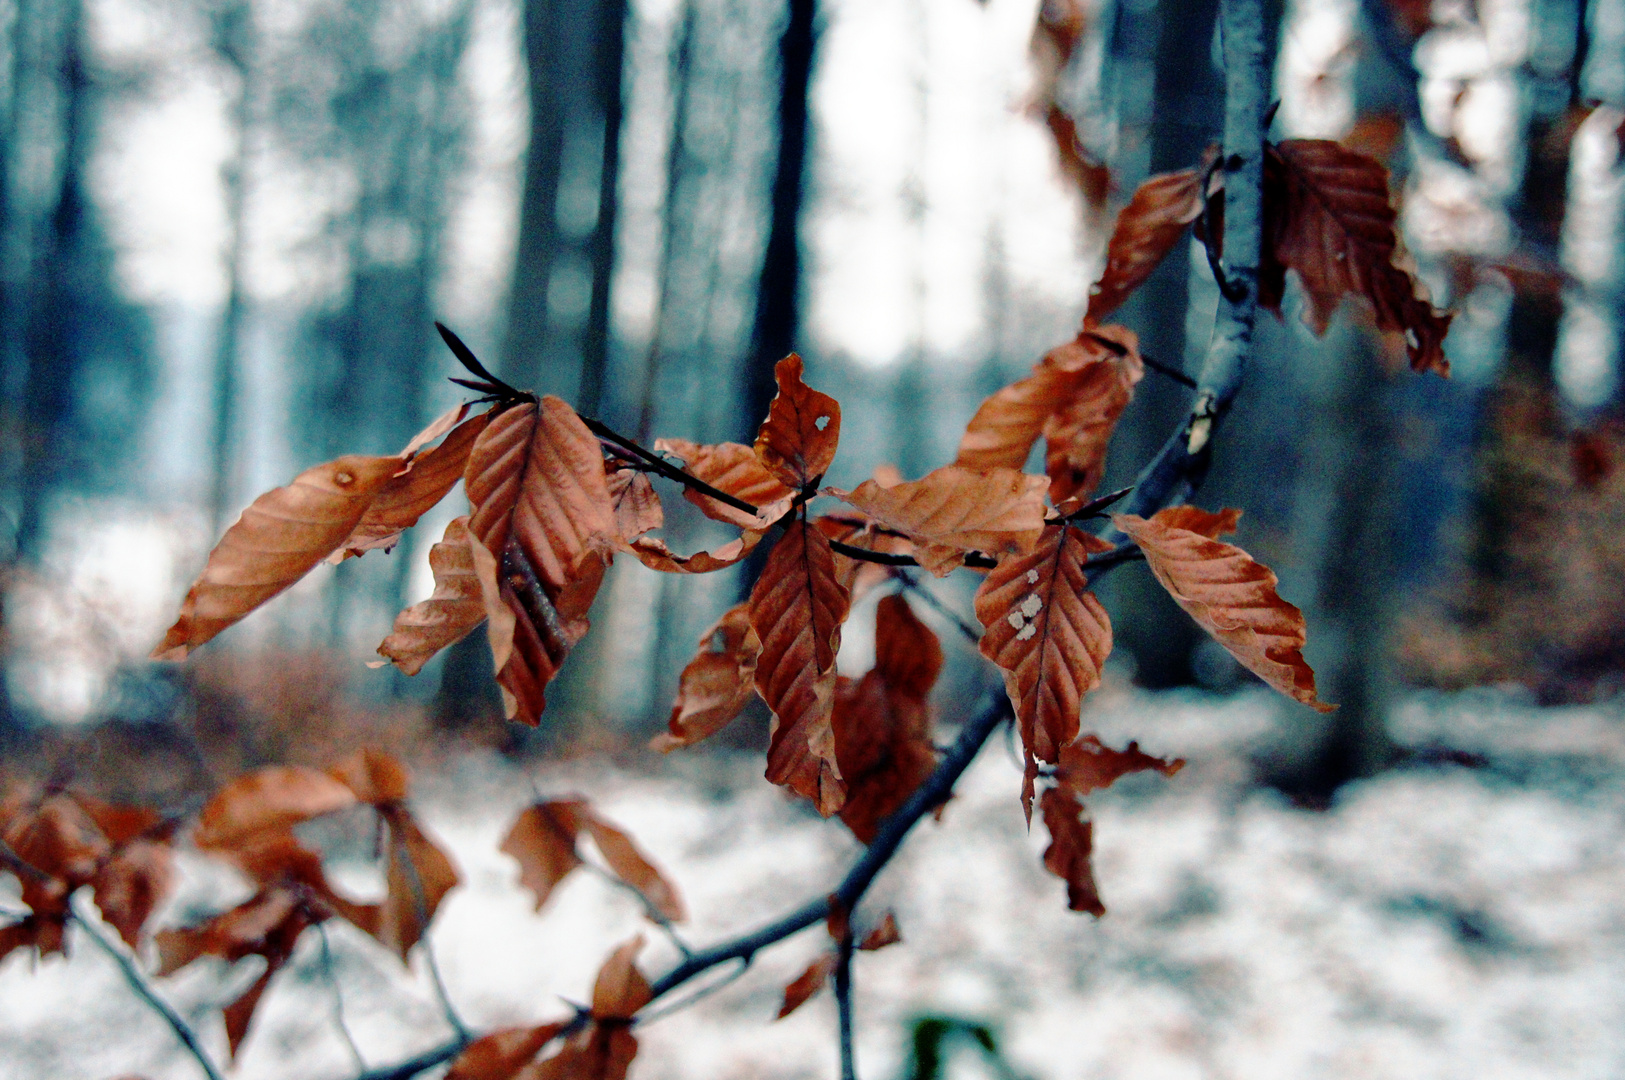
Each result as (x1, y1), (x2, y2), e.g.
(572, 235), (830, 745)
(834, 594), (943, 843)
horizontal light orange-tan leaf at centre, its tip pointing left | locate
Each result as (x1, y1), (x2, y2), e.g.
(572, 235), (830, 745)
(827, 464), (1050, 577)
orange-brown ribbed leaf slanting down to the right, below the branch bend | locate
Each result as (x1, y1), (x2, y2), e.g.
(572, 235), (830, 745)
(1112, 507), (1334, 713)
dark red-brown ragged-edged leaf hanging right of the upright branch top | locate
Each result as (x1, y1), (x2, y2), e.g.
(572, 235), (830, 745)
(1258, 140), (1453, 375)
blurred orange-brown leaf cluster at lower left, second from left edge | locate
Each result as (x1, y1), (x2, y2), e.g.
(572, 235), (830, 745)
(154, 750), (458, 1054)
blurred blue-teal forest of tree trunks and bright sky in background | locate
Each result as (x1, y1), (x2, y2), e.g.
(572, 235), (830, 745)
(0, 0), (1625, 804)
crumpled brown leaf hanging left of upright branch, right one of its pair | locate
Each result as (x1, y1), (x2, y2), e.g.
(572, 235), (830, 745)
(1043, 326), (1146, 505)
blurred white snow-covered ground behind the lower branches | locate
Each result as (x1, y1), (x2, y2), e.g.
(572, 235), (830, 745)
(0, 692), (1625, 1080)
